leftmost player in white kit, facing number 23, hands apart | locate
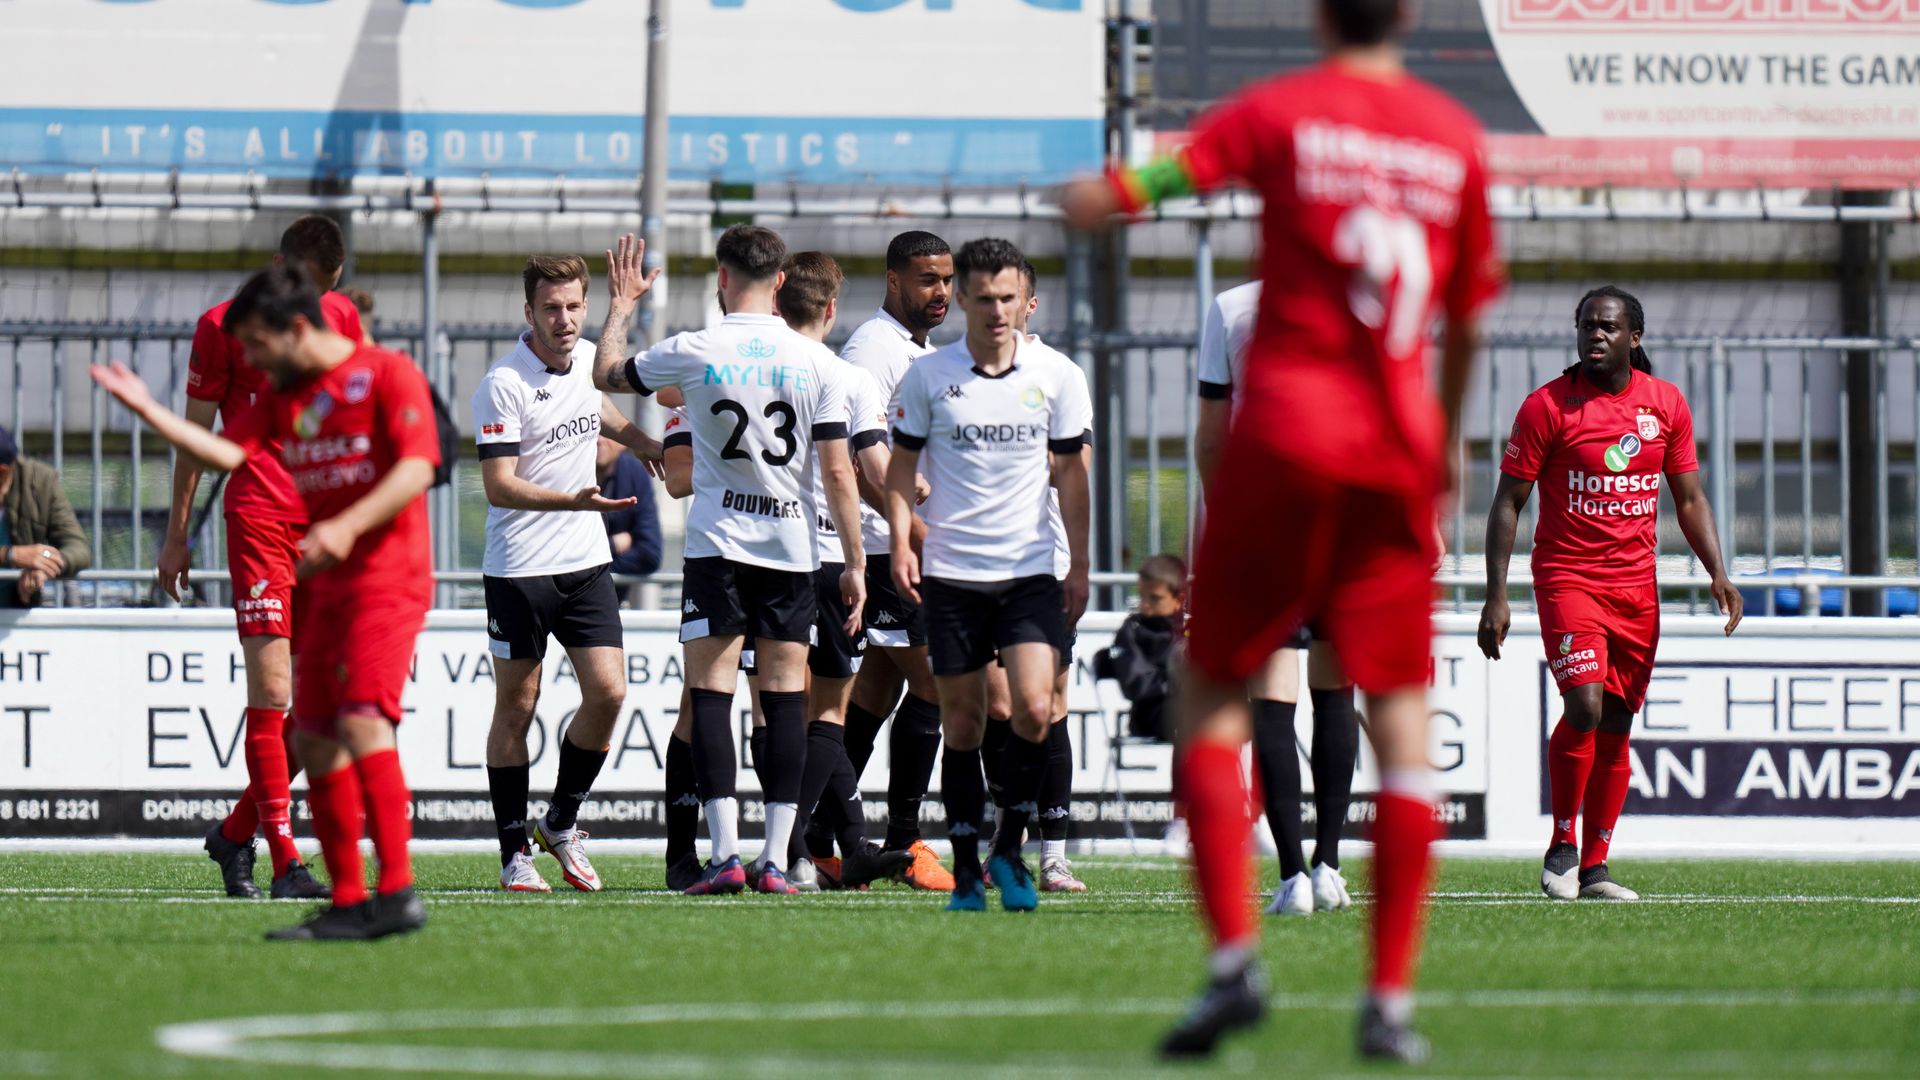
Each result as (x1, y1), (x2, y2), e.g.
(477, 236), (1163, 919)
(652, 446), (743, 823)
(472, 256), (660, 892)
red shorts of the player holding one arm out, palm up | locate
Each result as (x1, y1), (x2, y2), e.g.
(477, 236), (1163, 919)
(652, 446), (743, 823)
(294, 575), (432, 738)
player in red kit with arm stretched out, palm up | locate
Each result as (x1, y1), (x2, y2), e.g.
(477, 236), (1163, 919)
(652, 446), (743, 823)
(92, 267), (440, 940)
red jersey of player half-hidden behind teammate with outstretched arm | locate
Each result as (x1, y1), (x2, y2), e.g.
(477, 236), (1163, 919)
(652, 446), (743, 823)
(186, 292), (361, 523)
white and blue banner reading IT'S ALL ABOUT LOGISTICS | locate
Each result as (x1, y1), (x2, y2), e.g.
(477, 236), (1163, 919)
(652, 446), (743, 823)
(0, 0), (1106, 184)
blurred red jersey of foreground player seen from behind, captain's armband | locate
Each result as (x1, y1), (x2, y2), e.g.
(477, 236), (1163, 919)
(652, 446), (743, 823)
(1187, 63), (1503, 492)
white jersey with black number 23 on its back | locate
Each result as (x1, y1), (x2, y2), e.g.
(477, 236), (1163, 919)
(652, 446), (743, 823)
(626, 313), (847, 571)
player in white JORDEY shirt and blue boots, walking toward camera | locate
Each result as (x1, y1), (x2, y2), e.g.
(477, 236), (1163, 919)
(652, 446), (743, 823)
(887, 240), (1092, 911)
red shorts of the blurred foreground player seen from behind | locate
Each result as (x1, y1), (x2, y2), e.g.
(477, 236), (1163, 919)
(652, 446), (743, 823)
(1187, 438), (1434, 694)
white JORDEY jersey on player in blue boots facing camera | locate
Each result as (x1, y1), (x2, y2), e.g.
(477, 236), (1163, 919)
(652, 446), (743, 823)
(893, 340), (1092, 582)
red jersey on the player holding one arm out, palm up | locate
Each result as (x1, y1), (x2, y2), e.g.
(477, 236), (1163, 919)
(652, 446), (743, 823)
(227, 346), (440, 598)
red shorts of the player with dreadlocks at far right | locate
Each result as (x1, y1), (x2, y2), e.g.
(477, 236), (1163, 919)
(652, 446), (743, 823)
(1534, 584), (1661, 713)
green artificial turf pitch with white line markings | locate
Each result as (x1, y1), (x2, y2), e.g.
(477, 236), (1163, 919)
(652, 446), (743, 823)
(0, 853), (1920, 1080)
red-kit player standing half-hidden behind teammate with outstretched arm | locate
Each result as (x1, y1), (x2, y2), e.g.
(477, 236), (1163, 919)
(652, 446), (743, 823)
(157, 213), (361, 899)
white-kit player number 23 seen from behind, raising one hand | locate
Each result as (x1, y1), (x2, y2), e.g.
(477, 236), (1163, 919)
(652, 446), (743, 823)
(595, 225), (866, 896)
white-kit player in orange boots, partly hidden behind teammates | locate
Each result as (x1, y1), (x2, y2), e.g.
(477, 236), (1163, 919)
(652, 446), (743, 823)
(837, 231), (954, 892)
